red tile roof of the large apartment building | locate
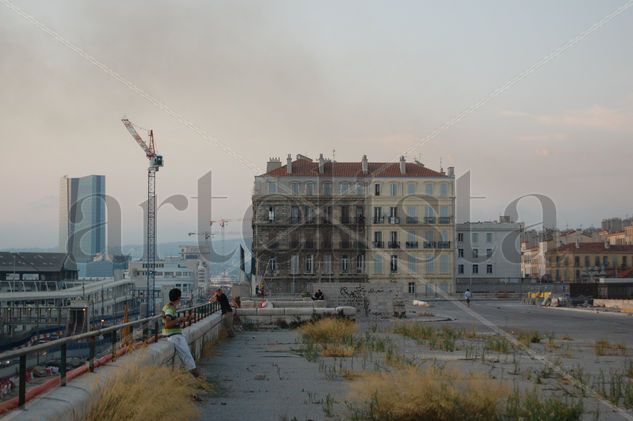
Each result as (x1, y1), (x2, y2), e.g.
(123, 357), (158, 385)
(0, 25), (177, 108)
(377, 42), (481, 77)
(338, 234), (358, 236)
(263, 159), (446, 177)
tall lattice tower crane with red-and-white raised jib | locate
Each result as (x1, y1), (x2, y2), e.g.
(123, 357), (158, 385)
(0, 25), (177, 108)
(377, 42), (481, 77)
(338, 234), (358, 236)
(121, 118), (163, 317)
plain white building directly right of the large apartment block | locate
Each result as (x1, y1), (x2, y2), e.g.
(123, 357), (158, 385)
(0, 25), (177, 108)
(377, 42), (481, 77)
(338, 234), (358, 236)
(455, 217), (523, 291)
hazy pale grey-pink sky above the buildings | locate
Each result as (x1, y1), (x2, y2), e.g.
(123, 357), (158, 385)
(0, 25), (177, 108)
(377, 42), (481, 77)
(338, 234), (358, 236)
(0, 0), (633, 248)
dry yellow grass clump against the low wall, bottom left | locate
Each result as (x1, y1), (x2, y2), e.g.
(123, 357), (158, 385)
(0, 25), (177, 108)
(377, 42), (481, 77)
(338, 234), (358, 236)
(85, 363), (201, 421)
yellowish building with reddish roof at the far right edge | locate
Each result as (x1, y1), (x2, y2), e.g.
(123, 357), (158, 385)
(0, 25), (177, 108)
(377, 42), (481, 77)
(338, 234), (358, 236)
(547, 241), (633, 282)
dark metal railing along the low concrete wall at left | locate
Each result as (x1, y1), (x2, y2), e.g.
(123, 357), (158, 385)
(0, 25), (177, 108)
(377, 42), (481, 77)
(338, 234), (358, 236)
(0, 302), (220, 409)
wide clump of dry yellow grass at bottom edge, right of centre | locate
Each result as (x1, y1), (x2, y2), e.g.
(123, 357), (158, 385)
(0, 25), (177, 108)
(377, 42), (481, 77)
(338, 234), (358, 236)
(350, 367), (510, 421)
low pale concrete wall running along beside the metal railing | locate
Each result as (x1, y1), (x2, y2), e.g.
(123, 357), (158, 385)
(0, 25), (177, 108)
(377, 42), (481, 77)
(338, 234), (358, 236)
(2, 313), (221, 421)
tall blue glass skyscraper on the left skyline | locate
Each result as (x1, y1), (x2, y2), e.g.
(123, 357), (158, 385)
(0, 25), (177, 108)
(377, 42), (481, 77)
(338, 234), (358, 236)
(59, 175), (106, 263)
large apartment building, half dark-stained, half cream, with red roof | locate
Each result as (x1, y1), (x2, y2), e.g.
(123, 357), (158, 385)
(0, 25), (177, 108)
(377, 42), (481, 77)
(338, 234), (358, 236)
(253, 155), (455, 293)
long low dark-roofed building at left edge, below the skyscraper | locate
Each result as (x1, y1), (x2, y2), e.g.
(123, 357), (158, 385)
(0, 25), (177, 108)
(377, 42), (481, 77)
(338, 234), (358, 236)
(0, 252), (78, 292)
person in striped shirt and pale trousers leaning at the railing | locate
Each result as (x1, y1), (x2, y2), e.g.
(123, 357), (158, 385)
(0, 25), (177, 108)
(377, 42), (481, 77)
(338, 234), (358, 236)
(162, 288), (200, 377)
